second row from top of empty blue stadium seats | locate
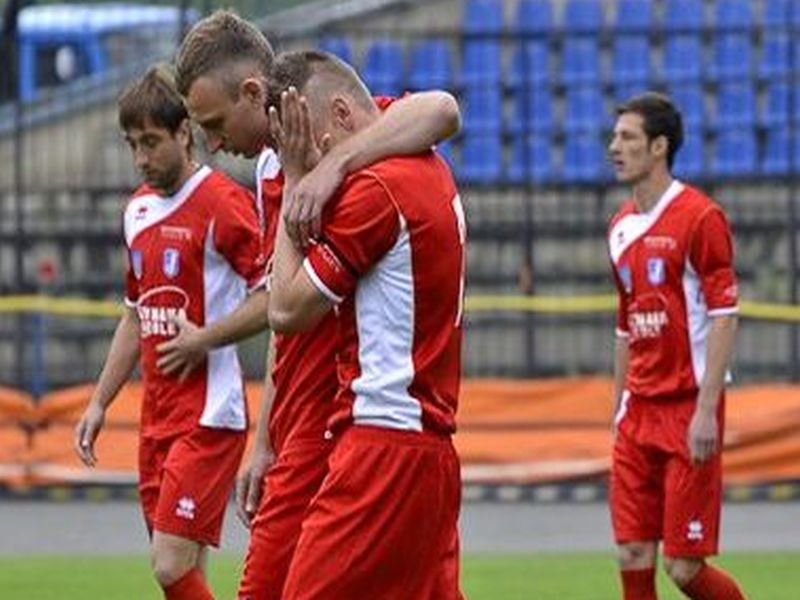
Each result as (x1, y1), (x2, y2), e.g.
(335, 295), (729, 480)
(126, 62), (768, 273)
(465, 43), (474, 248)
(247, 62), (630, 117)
(320, 34), (800, 94)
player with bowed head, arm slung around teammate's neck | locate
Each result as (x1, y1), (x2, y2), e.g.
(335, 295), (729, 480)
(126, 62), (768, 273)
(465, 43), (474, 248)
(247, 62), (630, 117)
(170, 11), (460, 600)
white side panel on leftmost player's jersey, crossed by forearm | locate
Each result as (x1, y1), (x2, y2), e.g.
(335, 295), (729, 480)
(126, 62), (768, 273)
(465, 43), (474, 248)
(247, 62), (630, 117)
(200, 222), (247, 431)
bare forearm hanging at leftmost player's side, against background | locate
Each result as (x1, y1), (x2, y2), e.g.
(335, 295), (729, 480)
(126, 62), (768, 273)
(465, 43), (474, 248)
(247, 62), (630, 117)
(91, 309), (139, 410)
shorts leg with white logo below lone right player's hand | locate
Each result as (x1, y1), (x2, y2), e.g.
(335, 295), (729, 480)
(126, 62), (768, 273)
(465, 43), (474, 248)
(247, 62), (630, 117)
(664, 454), (722, 558)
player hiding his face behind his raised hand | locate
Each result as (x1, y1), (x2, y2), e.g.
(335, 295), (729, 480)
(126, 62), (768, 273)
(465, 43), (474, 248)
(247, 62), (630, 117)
(270, 51), (466, 600)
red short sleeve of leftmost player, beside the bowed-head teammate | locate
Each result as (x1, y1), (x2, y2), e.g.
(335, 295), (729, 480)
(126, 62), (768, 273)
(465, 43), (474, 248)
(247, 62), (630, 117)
(214, 185), (266, 291)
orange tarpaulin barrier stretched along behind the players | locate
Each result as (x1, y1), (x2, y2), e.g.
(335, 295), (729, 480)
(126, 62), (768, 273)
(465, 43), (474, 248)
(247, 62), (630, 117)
(0, 377), (800, 485)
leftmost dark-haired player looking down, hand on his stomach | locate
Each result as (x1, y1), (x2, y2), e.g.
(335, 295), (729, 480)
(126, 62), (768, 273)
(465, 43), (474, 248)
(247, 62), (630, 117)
(75, 67), (268, 600)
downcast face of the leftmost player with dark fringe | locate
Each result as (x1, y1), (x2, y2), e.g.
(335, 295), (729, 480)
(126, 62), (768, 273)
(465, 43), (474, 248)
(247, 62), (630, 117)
(125, 120), (191, 194)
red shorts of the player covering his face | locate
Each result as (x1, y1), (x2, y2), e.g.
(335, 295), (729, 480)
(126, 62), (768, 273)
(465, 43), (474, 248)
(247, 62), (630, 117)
(283, 426), (461, 600)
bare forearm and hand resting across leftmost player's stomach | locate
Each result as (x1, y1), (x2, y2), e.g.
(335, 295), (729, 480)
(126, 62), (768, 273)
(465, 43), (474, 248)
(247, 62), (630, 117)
(156, 289), (269, 381)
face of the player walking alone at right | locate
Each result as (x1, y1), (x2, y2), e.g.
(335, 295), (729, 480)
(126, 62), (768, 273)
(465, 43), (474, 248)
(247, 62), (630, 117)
(608, 113), (663, 185)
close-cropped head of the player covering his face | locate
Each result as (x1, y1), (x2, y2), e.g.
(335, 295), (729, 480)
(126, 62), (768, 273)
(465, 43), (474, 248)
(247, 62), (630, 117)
(270, 50), (378, 152)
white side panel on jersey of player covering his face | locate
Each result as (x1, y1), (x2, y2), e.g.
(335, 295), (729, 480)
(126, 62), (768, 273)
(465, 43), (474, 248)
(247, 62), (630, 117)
(351, 216), (422, 431)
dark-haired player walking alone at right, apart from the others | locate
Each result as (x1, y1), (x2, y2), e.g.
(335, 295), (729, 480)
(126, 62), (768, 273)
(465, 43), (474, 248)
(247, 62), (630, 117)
(608, 93), (744, 600)
